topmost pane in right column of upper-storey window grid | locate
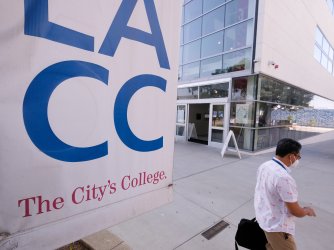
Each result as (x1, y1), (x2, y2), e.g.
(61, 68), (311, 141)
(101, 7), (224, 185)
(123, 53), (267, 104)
(225, 0), (252, 26)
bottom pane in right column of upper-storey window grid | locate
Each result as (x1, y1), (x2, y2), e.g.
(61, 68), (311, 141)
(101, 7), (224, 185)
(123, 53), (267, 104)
(223, 49), (251, 73)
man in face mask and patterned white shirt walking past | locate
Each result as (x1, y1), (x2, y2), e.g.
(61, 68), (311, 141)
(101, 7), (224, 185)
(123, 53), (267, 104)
(254, 138), (315, 250)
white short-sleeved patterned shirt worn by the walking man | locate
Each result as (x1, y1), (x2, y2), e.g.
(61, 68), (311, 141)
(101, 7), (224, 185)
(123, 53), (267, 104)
(254, 158), (298, 235)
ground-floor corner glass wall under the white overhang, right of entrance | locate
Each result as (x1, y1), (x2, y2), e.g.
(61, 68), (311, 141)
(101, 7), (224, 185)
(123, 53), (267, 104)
(230, 75), (334, 151)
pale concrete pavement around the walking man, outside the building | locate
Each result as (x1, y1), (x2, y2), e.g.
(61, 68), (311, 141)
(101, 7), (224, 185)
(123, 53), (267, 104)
(109, 132), (334, 250)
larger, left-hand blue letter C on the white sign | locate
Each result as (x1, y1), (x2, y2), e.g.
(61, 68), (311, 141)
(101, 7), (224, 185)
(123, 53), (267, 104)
(23, 61), (109, 162)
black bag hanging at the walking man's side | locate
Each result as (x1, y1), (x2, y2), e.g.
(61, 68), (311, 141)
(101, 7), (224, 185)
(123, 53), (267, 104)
(235, 218), (267, 250)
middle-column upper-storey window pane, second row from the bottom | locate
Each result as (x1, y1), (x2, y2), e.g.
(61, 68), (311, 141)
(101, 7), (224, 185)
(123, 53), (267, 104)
(201, 31), (223, 57)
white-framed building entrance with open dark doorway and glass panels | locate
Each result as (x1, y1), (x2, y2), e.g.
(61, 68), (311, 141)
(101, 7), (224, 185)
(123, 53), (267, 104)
(175, 79), (231, 148)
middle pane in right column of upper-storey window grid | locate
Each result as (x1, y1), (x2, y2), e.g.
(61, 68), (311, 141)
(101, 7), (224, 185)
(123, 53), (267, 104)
(224, 21), (253, 51)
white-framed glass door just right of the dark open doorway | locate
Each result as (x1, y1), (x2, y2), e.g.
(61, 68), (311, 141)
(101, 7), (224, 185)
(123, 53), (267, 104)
(209, 104), (225, 148)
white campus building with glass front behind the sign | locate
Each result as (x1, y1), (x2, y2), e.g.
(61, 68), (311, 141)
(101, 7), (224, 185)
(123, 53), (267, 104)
(176, 0), (334, 151)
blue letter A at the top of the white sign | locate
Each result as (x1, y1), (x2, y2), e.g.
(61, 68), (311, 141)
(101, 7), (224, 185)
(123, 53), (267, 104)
(99, 0), (170, 69)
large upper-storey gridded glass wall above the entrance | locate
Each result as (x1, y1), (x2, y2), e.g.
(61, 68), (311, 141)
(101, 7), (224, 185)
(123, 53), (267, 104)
(179, 0), (255, 81)
